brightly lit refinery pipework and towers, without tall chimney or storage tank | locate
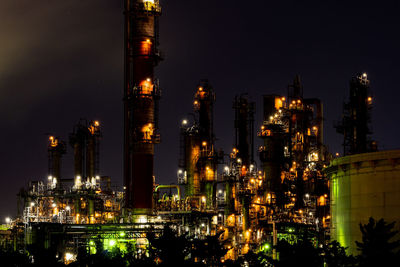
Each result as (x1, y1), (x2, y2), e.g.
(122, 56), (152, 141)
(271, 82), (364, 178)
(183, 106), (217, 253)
(9, 74), (330, 260)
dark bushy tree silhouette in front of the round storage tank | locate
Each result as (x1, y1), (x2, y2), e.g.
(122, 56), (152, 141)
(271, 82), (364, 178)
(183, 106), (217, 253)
(356, 217), (400, 266)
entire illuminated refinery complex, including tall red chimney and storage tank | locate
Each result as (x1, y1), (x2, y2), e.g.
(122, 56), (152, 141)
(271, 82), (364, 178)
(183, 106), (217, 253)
(2, 0), (400, 263)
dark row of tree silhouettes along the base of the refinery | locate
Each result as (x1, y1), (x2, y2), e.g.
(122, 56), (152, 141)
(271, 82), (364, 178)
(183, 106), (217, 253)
(0, 218), (400, 267)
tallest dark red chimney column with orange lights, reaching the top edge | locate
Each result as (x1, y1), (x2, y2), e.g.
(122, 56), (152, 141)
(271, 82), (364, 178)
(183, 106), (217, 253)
(124, 0), (161, 214)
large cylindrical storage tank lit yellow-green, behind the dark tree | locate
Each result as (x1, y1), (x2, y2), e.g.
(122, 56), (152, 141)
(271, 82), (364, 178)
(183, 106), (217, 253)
(324, 150), (400, 254)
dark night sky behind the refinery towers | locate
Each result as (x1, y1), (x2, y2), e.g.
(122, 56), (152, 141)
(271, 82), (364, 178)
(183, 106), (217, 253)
(0, 0), (400, 221)
